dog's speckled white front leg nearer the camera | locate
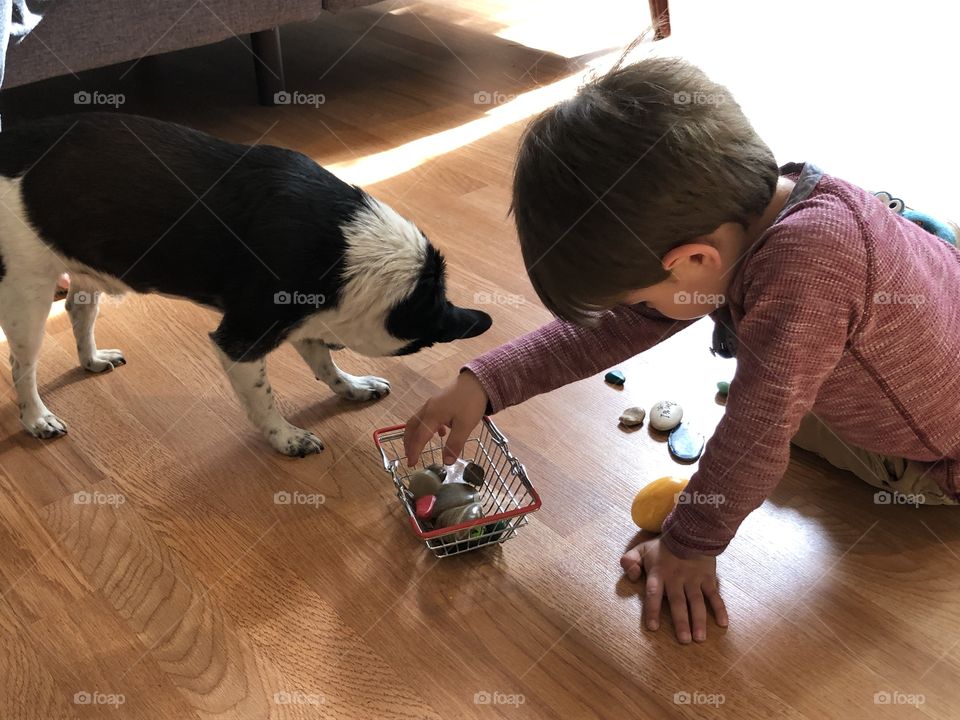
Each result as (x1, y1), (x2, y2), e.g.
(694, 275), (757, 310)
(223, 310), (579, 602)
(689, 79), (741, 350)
(214, 344), (323, 457)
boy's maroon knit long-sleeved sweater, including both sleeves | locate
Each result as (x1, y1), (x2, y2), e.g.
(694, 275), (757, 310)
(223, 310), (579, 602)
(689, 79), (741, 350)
(466, 165), (960, 557)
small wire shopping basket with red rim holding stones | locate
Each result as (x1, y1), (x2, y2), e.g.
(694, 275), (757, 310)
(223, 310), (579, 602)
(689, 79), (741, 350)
(373, 417), (540, 557)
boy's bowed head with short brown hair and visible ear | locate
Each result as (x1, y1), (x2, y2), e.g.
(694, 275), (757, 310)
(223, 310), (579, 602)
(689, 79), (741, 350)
(512, 58), (778, 323)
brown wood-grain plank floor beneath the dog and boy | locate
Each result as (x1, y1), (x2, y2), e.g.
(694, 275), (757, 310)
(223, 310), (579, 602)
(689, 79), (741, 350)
(0, 0), (960, 720)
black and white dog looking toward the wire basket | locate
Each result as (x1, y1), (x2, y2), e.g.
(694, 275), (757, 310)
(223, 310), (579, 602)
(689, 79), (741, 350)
(0, 114), (490, 457)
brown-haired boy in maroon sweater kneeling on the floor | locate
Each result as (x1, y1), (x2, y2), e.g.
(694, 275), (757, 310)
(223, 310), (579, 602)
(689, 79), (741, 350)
(405, 54), (960, 643)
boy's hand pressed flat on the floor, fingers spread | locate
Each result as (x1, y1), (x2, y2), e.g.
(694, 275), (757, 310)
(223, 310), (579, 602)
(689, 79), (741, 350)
(620, 538), (728, 644)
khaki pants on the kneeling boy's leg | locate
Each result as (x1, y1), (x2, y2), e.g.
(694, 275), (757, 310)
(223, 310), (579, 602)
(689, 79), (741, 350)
(791, 413), (957, 505)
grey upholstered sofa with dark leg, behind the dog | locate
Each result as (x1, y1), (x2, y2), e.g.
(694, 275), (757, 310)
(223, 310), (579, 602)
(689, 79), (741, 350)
(3, 0), (376, 104)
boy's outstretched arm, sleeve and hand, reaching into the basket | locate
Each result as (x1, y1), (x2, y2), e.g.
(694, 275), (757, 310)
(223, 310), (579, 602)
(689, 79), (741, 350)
(404, 305), (692, 464)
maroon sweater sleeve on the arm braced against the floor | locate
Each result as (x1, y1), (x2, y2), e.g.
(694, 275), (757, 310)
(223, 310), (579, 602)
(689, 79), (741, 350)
(661, 215), (869, 557)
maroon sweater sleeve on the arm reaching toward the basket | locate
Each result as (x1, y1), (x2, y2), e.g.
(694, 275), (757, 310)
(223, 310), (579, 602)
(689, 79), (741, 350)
(464, 305), (692, 412)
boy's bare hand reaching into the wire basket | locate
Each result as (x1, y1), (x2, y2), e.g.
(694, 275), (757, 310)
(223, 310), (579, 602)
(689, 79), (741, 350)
(403, 370), (487, 467)
